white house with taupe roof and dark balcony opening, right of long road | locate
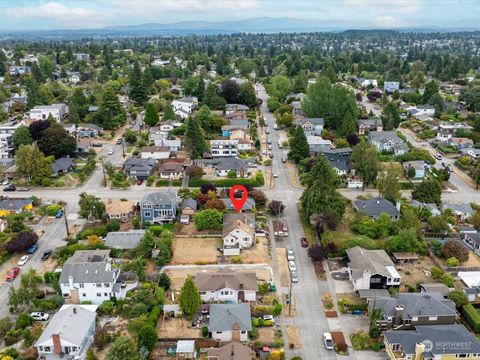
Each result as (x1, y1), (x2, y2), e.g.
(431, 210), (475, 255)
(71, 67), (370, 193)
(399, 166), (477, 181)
(346, 246), (401, 291)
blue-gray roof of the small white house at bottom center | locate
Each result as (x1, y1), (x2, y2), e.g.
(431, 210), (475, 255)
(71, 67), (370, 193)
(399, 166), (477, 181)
(208, 304), (252, 332)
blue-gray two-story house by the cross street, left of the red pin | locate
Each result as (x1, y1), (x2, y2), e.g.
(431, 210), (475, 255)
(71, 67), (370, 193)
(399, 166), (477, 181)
(140, 190), (177, 224)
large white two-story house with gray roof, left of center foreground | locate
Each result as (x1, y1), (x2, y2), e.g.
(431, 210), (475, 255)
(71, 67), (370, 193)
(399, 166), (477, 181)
(59, 250), (127, 305)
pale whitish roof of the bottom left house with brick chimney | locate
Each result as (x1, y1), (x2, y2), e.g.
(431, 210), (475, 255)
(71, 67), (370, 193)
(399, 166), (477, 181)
(35, 305), (96, 346)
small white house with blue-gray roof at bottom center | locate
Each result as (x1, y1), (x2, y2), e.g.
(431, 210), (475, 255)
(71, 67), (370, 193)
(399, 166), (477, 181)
(208, 304), (252, 341)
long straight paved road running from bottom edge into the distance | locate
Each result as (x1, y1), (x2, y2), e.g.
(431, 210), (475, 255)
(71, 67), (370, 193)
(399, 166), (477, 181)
(256, 85), (336, 359)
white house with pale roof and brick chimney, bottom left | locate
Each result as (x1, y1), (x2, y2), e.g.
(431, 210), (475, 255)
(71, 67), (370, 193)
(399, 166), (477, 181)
(34, 305), (97, 360)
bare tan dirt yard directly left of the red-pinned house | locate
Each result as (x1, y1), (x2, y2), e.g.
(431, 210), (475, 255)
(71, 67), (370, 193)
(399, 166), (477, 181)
(171, 237), (220, 265)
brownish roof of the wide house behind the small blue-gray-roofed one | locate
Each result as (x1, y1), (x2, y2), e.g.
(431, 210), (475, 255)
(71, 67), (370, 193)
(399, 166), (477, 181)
(195, 269), (258, 291)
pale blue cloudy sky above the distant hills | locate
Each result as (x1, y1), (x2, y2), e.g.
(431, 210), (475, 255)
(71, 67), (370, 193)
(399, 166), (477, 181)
(0, 0), (480, 30)
